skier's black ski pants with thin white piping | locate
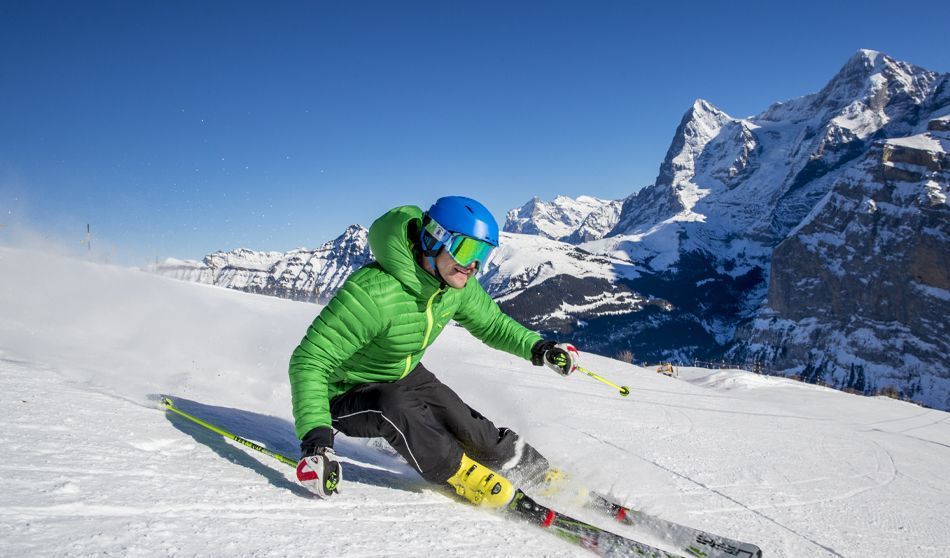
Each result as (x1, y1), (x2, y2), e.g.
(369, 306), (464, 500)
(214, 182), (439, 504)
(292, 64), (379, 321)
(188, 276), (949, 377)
(330, 364), (517, 483)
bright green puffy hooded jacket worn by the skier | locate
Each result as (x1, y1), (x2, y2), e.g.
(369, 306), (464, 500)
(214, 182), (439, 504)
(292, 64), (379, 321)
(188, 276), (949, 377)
(290, 206), (541, 438)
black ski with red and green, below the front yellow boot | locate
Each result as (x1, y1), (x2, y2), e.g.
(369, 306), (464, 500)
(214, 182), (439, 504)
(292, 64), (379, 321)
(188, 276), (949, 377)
(505, 489), (683, 558)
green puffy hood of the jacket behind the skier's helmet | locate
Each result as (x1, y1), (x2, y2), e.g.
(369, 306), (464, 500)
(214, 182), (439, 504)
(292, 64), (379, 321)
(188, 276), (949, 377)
(369, 205), (440, 297)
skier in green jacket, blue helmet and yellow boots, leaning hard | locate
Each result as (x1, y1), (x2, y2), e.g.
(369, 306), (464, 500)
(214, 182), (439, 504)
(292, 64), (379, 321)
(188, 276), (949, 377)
(289, 196), (578, 507)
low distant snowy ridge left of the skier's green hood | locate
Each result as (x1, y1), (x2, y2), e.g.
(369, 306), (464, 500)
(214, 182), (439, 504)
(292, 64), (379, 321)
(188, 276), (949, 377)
(147, 225), (372, 303)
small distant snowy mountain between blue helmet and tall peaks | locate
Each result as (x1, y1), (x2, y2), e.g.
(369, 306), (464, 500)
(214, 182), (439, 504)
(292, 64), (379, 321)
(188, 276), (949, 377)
(503, 196), (623, 244)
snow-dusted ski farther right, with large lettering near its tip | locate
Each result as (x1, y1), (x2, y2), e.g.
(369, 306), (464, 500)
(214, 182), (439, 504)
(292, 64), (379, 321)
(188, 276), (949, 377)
(587, 491), (762, 558)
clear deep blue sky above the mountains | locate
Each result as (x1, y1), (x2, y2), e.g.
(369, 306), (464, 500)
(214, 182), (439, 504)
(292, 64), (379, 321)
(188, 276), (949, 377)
(0, 0), (950, 265)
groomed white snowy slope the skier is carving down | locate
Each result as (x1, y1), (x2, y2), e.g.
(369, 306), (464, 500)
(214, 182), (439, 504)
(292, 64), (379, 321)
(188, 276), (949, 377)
(0, 248), (950, 557)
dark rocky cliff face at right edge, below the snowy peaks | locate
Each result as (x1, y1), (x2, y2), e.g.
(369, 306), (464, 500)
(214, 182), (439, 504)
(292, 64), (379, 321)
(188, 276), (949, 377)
(733, 126), (950, 408)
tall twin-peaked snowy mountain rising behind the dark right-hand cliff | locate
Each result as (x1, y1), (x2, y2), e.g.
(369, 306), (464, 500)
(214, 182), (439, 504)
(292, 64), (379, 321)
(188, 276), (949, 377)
(602, 50), (947, 269)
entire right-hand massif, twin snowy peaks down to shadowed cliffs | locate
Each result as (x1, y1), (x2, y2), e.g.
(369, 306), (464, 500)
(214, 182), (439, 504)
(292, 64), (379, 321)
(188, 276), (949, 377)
(494, 50), (950, 408)
